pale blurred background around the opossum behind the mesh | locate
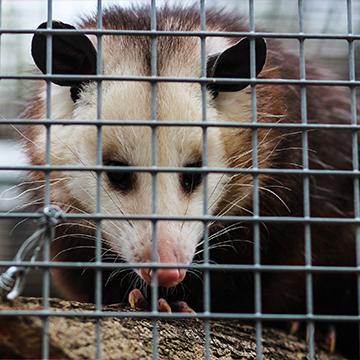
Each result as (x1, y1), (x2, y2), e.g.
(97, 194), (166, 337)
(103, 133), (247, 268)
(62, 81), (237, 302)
(0, 0), (360, 294)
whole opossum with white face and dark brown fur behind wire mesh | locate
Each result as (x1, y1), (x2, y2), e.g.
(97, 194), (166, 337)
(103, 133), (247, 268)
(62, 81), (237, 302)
(25, 6), (358, 356)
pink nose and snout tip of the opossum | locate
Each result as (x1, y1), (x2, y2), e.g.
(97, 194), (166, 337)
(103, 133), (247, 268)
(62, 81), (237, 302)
(138, 232), (186, 288)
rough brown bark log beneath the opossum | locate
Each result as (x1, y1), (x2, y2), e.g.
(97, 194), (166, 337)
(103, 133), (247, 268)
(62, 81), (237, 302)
(0, 298), (343, 360)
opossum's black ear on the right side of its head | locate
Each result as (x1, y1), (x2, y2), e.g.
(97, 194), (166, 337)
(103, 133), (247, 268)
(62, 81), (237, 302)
(207, 38), (266, 96)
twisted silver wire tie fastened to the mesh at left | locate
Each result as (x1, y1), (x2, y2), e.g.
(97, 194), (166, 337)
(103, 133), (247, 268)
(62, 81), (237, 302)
(0, 205), (63, 301)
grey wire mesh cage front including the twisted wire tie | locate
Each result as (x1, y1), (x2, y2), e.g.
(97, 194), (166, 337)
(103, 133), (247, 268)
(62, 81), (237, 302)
(0, 0), (360, 359)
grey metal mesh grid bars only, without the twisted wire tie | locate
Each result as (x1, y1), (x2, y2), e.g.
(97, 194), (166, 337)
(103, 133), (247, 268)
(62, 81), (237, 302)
(0, 0), (360, 360)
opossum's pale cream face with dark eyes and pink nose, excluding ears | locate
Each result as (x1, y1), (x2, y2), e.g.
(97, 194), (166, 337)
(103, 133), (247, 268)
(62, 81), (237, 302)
(45, 83), (227, 287)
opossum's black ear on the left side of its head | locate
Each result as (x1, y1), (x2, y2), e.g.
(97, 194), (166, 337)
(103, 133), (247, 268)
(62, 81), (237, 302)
(31, 21), (97, 101)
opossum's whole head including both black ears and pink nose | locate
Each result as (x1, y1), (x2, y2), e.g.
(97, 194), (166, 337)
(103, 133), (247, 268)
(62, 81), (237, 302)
(32, 22), (266, 287)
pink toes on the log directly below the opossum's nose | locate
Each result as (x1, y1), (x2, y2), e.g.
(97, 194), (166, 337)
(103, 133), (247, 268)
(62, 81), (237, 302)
(129, 289), (195, 313)
